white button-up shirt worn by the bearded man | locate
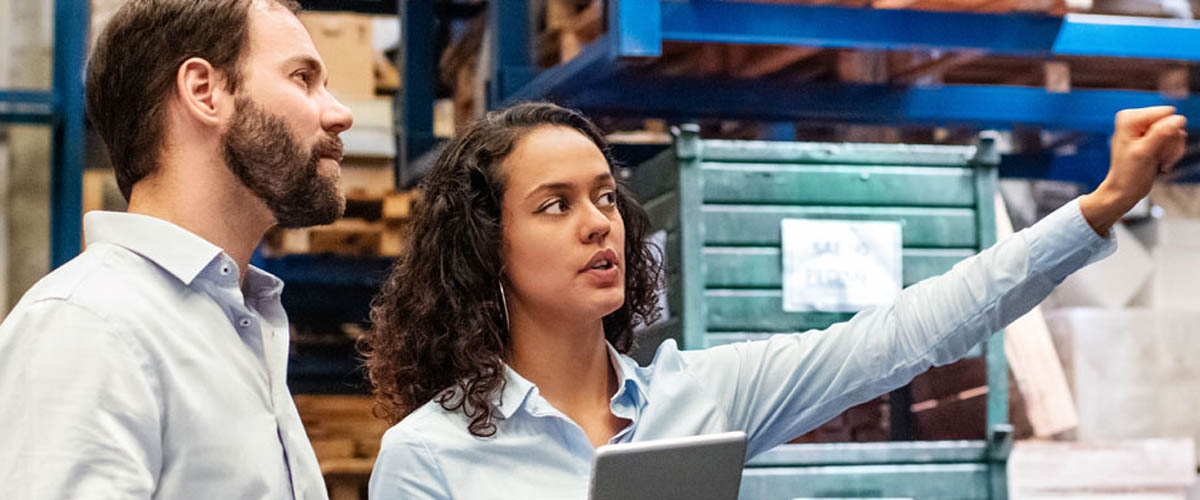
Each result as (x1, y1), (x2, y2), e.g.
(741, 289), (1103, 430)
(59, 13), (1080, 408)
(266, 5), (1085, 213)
(0, 212), (328, 500)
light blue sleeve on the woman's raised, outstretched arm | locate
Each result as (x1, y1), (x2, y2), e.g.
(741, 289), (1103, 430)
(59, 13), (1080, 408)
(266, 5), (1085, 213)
(684, 199), (1116, 457)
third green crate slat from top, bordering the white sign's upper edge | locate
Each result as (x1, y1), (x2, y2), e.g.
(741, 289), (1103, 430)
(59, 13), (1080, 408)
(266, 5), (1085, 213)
(703, 205), (978, 248)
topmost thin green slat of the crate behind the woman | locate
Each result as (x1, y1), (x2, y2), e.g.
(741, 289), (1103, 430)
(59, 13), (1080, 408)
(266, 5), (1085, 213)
(701, 140), (977, 167)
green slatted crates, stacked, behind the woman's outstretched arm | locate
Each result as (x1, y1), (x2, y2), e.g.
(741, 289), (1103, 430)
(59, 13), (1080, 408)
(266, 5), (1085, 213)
(630, 126), (1010, 500)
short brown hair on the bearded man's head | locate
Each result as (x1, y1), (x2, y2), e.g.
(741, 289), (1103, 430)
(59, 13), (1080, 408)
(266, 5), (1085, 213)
(88, 0), (300, 200)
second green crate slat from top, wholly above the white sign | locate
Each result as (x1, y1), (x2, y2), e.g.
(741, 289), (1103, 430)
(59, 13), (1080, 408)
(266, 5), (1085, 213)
(701, 163), (976, 207)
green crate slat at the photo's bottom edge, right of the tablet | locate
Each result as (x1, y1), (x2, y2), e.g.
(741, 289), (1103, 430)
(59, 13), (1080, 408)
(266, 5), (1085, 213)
(738, 463), (991, 500)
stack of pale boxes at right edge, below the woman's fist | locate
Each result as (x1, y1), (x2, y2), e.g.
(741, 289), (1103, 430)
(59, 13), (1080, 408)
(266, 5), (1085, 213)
(1046, 186), (1200, 460)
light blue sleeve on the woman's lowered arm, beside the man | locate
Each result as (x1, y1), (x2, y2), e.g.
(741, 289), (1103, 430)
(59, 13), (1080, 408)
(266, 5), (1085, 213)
(367, 432), (451, 500)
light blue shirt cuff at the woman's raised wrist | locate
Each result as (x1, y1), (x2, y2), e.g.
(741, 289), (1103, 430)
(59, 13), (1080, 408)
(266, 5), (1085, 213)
(1021, 198), (1117, 282)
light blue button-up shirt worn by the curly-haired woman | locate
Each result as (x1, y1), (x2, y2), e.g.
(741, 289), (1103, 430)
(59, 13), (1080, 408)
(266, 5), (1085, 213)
(371, 196), (1116, 500)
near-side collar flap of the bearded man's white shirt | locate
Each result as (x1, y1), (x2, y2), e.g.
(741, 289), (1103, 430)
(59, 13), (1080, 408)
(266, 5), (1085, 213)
(83, 211), (222, 285)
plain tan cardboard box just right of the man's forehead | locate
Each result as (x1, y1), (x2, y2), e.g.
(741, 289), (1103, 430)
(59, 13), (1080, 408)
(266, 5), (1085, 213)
(300, 12), (374, 101)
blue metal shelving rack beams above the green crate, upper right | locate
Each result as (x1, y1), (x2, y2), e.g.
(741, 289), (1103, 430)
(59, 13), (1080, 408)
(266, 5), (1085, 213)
(401, 0), (1200, 185)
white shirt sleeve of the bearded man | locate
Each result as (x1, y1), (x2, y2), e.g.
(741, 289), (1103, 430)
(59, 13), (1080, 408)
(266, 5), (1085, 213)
(0, 299), (162, 499)
